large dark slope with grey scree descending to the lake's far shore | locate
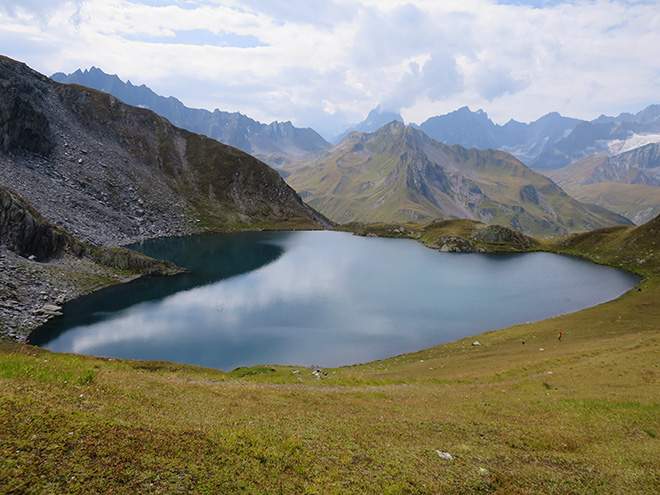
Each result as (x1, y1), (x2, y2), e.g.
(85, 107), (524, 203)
(0, 58), (327, 246)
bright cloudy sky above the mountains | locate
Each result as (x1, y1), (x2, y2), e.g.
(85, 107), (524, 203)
(0, 0), (660, 139)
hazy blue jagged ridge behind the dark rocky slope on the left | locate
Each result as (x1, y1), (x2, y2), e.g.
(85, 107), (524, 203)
(51, 67), (330, 166)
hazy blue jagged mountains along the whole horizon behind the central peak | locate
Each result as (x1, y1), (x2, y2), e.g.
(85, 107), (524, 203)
(51, 67), (660, 170)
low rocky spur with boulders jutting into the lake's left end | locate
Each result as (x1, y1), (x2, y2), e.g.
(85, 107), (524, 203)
(0, 186), (181, 341)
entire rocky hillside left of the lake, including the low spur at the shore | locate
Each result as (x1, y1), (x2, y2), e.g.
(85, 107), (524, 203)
(0, 57), (330, 339)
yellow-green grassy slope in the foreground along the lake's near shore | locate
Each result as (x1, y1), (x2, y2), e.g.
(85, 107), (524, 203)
(0, 219), (660, 494)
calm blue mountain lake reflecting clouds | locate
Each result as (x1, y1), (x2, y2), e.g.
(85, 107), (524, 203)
(30, 232), (638, 370)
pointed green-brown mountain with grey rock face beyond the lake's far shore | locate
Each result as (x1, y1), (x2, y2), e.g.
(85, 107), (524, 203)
(287, 121), (630, 237)
